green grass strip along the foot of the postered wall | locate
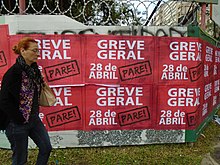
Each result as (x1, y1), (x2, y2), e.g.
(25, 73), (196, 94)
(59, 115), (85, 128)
(0, 121), (220, 165)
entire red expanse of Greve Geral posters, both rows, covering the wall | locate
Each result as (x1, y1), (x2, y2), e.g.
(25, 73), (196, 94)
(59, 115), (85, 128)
(0, 26), (220, 131)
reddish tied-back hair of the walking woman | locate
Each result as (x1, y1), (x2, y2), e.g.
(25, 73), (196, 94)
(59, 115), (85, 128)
(12, 37), (38, 54)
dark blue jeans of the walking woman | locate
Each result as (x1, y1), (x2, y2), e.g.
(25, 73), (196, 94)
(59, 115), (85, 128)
(6, 115), (52, 165)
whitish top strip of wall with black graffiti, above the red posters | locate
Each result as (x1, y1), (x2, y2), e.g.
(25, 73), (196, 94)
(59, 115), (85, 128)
(0, 15), (187, 37)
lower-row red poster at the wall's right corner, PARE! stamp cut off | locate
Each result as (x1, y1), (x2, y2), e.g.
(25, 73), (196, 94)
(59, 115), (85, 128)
(156, 85), (204, 130)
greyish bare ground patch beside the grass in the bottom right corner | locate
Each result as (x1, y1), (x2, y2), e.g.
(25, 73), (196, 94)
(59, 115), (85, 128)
(201, 143), (220, 165)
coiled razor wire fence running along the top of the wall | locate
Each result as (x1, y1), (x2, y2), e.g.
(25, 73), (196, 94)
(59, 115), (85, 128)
(0, 0), (205, 26)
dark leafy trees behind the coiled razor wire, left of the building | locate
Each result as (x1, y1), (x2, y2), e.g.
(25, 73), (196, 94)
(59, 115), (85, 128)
(0, 0), (140, 26)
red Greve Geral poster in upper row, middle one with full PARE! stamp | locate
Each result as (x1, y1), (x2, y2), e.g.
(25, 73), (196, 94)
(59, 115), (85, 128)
(85, 35), (156, 84)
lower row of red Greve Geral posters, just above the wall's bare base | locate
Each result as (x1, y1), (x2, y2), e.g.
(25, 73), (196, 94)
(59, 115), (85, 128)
(41, 80), (220, 131)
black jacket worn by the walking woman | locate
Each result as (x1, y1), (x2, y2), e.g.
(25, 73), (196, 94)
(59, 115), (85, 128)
(0, 63), (25, 129)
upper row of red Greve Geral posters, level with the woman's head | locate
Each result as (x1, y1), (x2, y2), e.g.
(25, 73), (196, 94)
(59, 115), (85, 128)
(4, 35), (220, 85)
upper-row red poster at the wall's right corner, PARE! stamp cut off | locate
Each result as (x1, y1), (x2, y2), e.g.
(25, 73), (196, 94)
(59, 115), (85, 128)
(156, 37), (204, 85)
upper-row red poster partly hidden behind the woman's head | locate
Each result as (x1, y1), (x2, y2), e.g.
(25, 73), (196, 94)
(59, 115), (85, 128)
(10, 35), (84, 86)
